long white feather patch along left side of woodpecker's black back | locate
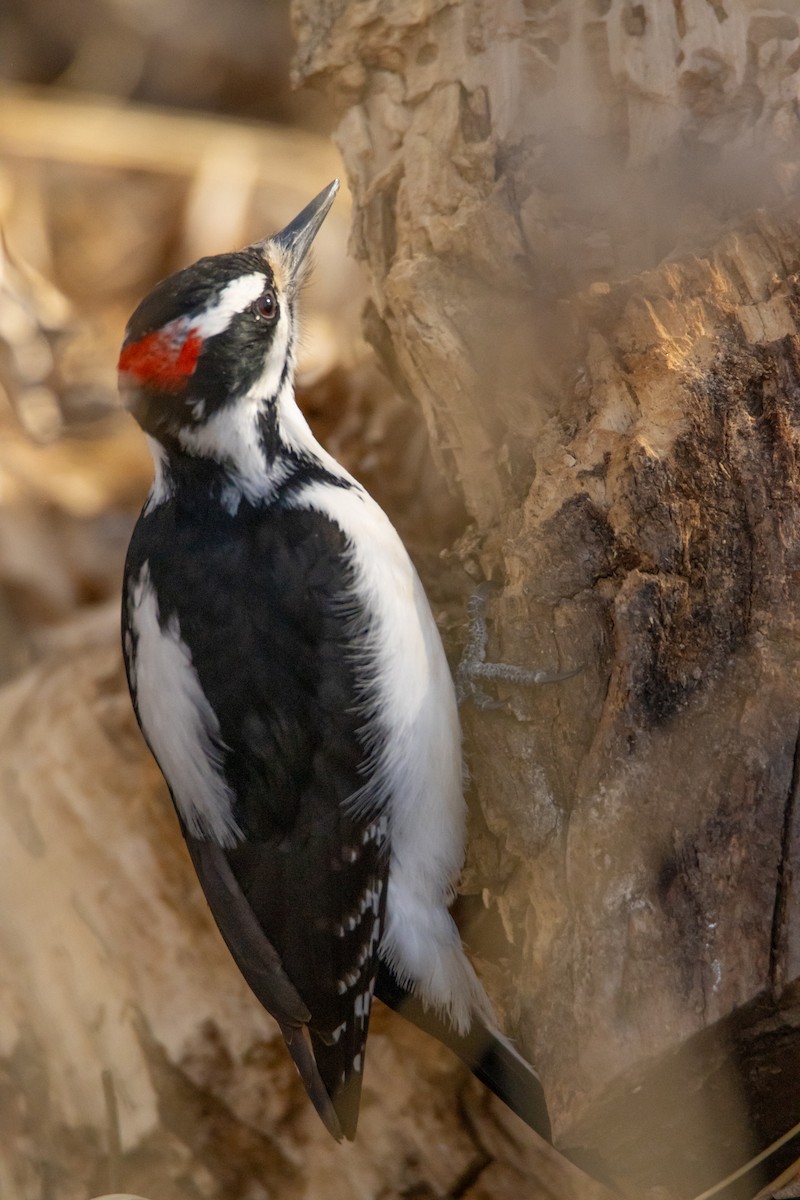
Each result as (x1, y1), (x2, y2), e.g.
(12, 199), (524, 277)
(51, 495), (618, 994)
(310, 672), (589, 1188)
(130, 563), (242, 847)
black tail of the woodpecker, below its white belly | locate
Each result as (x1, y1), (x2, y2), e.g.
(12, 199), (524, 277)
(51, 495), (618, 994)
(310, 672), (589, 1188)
(375, 962), (552, 1141)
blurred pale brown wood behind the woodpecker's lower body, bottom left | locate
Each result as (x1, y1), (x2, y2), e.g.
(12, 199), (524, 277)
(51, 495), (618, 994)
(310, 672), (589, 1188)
(0, 605), (606, 1200)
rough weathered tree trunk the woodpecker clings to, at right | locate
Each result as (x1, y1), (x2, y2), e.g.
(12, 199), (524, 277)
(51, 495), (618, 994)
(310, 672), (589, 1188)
(294, 0), (800, 1195)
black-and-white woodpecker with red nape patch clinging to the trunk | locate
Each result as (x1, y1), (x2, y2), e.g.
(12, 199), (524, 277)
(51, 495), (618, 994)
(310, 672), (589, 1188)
(119, 181), (549, 1139)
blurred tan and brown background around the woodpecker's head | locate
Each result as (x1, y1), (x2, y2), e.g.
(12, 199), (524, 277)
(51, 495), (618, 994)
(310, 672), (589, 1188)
(0, 0), (452, 696)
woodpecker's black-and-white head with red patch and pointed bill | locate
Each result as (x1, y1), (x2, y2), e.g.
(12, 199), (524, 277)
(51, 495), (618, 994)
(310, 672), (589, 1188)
(119, 180), (339, 448)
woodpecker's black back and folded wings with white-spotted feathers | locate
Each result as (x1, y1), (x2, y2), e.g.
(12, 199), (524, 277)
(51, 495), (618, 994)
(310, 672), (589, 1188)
(126, 484), (387, 1138)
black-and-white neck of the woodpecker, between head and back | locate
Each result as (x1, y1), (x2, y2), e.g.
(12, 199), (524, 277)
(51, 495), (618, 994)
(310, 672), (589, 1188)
(148, 380), (349, 511)
